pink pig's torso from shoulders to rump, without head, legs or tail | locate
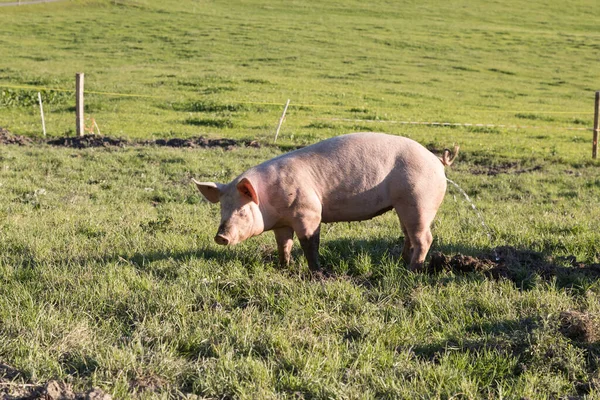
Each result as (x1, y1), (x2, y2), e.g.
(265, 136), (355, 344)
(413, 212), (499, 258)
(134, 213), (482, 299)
(253, 132), (446, 222)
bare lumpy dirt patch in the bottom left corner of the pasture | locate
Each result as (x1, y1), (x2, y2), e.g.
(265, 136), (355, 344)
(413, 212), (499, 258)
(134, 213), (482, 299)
(0, 363), (112, 400)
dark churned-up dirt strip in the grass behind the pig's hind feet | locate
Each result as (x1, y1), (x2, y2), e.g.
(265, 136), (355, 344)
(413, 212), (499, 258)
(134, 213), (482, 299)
(427, 246), (600, 280)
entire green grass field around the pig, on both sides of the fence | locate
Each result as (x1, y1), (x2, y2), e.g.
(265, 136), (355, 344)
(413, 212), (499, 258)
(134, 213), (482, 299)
(0, 0), (600, 399)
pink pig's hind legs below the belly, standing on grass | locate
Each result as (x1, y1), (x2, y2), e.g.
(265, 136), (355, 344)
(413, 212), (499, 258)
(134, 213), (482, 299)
(394, 206), (435, 271)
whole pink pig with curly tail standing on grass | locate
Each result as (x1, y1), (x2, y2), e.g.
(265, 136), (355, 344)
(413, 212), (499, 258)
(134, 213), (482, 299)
(193, 132), (458, 271)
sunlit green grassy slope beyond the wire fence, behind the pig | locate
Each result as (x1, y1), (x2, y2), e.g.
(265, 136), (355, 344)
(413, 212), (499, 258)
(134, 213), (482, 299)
(0, 1), (600, 154)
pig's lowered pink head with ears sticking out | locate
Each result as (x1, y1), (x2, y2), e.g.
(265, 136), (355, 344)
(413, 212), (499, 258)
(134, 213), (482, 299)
(193, 178), (264, 246)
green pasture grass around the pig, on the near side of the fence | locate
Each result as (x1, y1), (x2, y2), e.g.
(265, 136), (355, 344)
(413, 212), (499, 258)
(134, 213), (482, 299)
(0, 147), (600, 398)
